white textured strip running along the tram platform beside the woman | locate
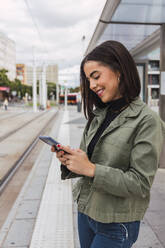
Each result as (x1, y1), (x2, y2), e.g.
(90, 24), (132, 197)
(30, 111), (74, 248)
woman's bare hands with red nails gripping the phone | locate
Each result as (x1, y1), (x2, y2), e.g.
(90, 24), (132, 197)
(51, 145), (95, 177)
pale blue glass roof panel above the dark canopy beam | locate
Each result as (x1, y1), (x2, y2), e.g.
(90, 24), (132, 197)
(112, 0), (165, 23)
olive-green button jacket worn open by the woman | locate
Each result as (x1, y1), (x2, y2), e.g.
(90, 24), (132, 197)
(61, 98), (165, 223)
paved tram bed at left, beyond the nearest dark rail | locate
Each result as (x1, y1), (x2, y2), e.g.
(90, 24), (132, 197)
(0, 109), (57, 183)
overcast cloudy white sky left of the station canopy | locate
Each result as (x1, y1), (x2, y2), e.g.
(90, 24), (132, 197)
(0, 0), (106, 86)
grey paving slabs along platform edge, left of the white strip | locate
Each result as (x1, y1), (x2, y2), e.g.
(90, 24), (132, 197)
(0, 109), (63, 248)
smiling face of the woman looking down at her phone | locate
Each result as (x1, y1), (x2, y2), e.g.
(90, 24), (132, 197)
(84, 61), (121, 103)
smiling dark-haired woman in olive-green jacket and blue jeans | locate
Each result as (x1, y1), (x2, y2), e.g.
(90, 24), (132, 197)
(52, 41), (164, 248)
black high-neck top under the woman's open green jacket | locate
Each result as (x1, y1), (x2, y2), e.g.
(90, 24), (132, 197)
(87, 98), (128, 159)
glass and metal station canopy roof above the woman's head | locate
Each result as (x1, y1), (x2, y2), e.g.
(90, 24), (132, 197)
(86, 0), (165, 53)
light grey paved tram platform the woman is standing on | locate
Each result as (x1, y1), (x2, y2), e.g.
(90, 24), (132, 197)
(0, 106), (165, 248)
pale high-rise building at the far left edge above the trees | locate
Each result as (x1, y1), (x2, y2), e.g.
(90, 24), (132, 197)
(0, 32), (16, 81)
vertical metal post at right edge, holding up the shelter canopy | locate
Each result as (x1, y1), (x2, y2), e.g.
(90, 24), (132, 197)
(159, 24), (165, 121)
